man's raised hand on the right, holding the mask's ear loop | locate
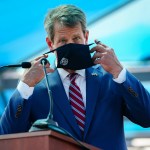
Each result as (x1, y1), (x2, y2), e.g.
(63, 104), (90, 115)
(91, 40), (123, 78)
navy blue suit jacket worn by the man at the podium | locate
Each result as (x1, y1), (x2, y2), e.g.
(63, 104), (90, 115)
(0, 67), (150, 150)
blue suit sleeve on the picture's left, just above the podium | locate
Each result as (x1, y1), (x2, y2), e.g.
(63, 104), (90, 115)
(0, 90), (31, 134)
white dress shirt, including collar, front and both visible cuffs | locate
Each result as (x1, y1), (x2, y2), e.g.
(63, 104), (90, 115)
(17, 68), (126, 107)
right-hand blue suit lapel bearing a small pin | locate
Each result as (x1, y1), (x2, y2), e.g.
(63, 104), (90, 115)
(84, 68), (100, 139)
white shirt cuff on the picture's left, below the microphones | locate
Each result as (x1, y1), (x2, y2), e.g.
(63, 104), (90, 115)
(17, 81), (34, 100)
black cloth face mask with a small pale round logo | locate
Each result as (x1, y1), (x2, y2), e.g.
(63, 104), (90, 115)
(44, 43), (94, 70)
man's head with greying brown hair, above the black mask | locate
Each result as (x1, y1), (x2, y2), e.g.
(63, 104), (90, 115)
(44, 5), (88, 49)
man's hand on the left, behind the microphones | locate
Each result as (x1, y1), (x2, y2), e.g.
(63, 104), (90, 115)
(21, 55), (54, 87)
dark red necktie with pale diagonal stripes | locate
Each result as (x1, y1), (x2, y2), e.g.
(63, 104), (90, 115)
(69, 73), (85, 134)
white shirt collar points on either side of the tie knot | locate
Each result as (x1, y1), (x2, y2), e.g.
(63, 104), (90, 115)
(57, 68), (85, 81)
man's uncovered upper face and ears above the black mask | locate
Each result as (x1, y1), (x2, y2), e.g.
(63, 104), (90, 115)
(48, 23), (88, 50)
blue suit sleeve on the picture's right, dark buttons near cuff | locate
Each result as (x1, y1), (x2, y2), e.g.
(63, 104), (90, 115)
(119, 71), (150, 127)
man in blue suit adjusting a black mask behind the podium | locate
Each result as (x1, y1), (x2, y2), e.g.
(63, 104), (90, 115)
(0, 5), (150, 150)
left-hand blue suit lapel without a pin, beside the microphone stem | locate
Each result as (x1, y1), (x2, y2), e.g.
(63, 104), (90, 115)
(49, 70), (81, 137)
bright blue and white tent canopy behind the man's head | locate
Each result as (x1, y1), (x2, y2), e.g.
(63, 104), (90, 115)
(0, 0), (150, 66)
